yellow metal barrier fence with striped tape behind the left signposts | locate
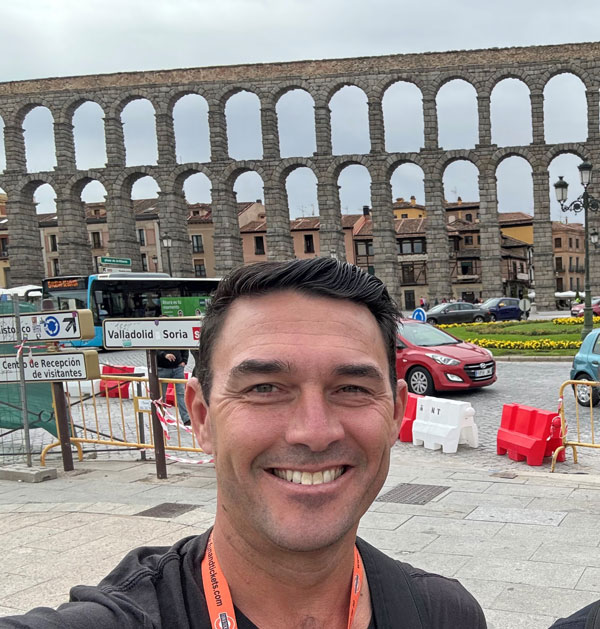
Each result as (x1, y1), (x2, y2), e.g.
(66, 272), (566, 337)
(40, 374), (210, 465)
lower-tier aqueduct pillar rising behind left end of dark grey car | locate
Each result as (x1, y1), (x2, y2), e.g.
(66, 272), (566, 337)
(425, 173), (455, 304)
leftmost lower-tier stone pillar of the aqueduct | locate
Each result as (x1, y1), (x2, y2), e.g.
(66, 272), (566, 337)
(6, 193), (46, 286)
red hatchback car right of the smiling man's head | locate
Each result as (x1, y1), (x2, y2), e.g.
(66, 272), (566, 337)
(396, 319), (496, 395)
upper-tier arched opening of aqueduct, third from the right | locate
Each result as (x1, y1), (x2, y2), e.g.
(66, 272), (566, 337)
(435, 79), (479, 150)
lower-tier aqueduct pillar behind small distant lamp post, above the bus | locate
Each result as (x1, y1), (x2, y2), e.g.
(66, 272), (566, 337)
(158, 192), (194, 277)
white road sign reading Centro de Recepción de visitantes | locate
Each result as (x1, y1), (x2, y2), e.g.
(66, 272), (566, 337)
(0, 349), (100, 384)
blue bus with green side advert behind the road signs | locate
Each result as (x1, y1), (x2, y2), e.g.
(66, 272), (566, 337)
(42, 272), (219, 348)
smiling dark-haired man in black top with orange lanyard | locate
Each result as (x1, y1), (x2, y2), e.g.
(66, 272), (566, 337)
(0, 258), (486, 629)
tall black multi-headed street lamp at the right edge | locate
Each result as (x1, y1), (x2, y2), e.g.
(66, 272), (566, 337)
(554, 162), (600, 341)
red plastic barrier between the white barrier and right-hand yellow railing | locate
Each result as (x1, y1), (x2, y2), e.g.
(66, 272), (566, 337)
(496, 404), (561, 465)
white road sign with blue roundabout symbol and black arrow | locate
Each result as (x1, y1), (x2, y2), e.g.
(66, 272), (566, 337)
(0, 310), (95, 343)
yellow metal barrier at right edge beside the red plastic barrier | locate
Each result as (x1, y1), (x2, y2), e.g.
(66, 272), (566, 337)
(551, 380), (600, 472)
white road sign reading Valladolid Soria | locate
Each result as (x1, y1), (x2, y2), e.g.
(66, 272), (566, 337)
(102, 317), (202, 349)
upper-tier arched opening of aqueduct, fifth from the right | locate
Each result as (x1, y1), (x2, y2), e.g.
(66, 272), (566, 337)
(329, 85), (371, 155)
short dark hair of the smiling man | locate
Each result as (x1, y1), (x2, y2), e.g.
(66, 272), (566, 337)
(194, 258), (400, 404)
